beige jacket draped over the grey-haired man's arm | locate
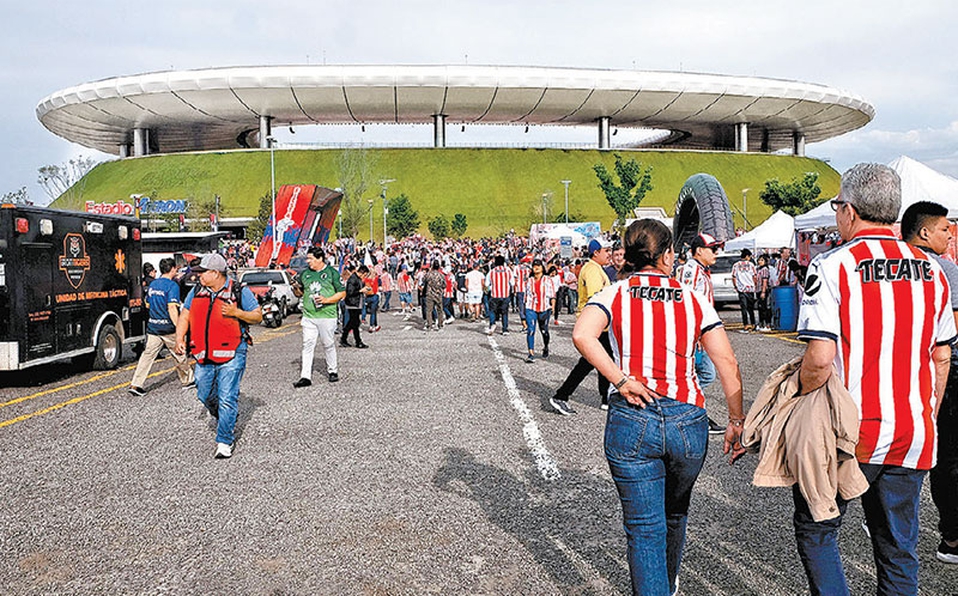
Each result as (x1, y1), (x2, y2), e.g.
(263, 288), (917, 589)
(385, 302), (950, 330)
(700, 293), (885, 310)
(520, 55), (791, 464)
(742, 357), (868, 521)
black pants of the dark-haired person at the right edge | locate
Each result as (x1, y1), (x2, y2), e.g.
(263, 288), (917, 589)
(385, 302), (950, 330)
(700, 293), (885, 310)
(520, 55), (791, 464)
(930, 360), (958, 542)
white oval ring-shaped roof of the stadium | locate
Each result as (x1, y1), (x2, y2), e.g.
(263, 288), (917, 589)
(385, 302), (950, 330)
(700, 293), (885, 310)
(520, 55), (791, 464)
(37, 65), (875, 154)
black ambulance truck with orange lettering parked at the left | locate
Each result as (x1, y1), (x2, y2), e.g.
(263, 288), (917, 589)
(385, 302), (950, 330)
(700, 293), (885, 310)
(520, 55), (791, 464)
(0, 204), (146, 370)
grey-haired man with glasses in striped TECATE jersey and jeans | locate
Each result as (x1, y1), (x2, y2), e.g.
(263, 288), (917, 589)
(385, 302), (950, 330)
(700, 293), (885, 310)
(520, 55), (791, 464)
(793, 164), (956, 594)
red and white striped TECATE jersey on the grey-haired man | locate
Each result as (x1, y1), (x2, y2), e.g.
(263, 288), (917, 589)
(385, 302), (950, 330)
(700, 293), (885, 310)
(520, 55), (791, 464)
(798, 228), (956, 470)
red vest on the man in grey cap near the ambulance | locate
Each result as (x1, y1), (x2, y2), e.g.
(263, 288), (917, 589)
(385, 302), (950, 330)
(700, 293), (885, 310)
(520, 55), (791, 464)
(190, 281), (243, 364)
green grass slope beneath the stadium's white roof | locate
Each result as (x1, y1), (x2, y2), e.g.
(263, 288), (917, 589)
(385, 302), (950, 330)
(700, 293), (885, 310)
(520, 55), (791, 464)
(53, 148), (840, 238)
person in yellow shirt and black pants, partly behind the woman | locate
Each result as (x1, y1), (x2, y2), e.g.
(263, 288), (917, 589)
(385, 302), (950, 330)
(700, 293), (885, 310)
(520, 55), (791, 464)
(549, 237), (612, 416)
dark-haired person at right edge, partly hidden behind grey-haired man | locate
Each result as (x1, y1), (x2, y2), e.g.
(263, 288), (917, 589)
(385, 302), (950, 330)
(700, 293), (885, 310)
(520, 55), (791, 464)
(901, 201), (958, 564)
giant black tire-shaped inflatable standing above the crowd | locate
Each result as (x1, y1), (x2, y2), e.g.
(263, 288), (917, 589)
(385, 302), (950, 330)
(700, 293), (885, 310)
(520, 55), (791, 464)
(672, 174), (735, 252)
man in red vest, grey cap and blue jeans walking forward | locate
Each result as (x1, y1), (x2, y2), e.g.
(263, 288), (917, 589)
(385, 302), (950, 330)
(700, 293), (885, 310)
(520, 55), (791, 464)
(174, 253), (263, 459)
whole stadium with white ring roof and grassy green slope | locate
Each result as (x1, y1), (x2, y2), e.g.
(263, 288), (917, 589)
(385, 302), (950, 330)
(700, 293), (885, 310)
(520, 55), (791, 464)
(37, 65), (874, 238)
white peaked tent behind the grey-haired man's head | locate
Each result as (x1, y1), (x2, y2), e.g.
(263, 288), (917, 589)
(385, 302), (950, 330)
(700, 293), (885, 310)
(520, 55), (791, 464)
(795, 155), (958, 231)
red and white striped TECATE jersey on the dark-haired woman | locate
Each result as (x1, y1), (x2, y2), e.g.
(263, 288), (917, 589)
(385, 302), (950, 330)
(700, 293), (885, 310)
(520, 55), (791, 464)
(587, 273), (722, 408)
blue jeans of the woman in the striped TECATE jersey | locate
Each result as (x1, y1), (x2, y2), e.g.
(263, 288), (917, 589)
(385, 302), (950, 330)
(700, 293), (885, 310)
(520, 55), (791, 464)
(605, 394), (708, 596)
